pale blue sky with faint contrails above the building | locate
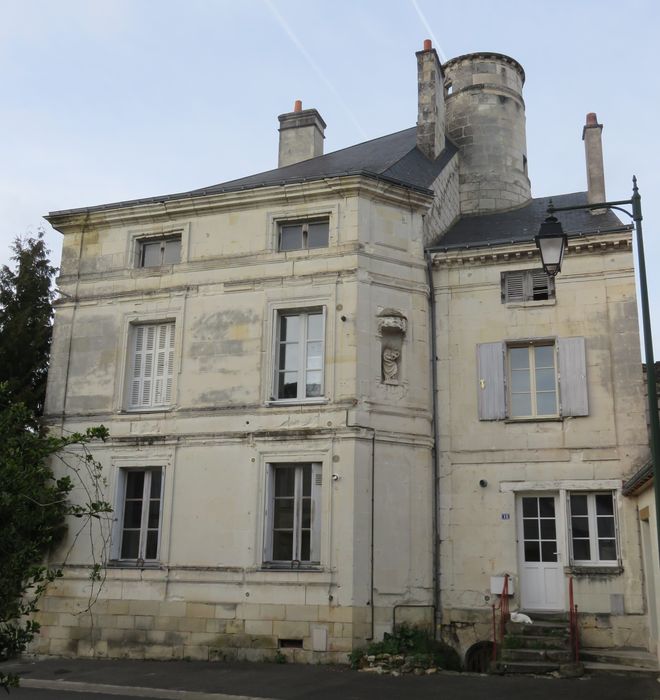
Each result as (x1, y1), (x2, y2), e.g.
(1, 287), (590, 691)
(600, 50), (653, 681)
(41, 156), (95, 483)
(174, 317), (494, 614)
(0, 0), (660, 350)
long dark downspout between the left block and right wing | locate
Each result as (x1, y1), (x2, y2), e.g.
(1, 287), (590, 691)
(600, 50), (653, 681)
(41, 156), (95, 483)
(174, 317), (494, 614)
(424, 250), (442, 638)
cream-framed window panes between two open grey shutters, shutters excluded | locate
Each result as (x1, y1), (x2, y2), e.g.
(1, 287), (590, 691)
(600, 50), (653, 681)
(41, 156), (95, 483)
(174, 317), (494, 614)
(508, 344), (557, 418)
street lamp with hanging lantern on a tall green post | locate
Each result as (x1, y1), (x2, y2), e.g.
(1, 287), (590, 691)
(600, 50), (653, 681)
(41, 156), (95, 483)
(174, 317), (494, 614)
(535, 176), (660, 547)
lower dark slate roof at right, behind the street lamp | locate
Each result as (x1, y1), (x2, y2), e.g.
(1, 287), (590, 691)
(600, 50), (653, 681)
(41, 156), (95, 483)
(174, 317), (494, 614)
(430, 192), (623, 251)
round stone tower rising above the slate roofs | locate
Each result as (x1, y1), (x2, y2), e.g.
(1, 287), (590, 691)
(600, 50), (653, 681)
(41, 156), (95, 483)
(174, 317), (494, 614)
(442, 53), (532, 214)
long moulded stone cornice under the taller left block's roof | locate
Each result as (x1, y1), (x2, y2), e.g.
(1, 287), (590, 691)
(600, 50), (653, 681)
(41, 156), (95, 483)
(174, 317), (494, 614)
(46, 173), (433, 234)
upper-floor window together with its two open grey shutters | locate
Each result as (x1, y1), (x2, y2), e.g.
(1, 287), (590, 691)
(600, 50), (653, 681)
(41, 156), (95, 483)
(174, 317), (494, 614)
(477, 337), (589, 420)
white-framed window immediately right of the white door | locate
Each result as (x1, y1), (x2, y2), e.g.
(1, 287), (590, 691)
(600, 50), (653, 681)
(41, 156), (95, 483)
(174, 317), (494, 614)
(569, 493), (618, 566)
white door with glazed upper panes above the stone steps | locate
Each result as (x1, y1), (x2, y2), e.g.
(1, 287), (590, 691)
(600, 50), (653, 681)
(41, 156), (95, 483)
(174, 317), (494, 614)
(518, 495), (565, 610)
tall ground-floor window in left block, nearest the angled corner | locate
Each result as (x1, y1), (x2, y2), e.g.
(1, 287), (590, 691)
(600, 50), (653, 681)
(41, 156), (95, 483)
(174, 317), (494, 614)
(265, 463), (322, 567)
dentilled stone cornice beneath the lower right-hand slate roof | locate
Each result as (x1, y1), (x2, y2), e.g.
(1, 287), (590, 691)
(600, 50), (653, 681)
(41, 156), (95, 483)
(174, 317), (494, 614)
(432, 230), (632, 267)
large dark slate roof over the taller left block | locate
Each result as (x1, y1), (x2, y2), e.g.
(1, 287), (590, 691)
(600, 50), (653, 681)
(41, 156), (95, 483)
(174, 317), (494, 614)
(50, 127), (458, 216)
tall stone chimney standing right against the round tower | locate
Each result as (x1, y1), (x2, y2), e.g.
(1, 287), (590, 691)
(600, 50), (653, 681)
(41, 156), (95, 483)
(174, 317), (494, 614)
(415, 39), (445, 160)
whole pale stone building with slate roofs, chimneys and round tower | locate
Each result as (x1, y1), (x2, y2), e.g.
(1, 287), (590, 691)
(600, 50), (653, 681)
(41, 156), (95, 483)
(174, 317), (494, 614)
(37, 42), (648, 661)
